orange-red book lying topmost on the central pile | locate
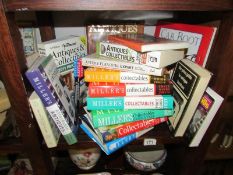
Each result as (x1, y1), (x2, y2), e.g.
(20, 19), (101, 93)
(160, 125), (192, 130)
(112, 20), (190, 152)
(108, 34), (189, 52)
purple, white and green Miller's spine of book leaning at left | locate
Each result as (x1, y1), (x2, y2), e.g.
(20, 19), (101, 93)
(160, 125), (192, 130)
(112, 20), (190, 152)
(26, 70), (77, 144)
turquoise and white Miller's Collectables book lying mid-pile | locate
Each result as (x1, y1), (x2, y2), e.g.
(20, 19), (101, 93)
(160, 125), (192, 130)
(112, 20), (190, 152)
(87, 95), (173, 110)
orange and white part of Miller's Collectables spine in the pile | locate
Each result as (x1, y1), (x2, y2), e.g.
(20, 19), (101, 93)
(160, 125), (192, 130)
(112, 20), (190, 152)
(84, 69), (150, 83)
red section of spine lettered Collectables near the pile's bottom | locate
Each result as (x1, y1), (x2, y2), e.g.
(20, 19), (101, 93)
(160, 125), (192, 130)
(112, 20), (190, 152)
(116, 117), (168, 138)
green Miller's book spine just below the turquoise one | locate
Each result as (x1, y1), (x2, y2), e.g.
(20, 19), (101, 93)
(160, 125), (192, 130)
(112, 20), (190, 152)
(91, 109), (174, 128)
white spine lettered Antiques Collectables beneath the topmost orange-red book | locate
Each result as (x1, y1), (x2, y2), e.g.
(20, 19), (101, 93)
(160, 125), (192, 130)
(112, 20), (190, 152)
(96, 41), (168, 68)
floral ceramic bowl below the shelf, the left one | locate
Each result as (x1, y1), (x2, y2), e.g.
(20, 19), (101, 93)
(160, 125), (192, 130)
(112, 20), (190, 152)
(69, 147), (101, 170)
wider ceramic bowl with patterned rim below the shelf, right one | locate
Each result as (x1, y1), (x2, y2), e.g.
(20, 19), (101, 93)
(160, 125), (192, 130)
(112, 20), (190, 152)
(125, 149), (167, 171)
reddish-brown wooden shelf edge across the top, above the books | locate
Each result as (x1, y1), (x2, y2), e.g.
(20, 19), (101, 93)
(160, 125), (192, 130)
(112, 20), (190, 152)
(5, 0), (233, 11)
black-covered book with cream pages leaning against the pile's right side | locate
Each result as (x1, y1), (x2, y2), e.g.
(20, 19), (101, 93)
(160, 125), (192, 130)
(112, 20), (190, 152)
(169, 59), (212, 136)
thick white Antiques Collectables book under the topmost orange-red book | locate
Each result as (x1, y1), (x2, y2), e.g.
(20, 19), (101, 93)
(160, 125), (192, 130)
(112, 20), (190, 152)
(96, 41), (185, 69)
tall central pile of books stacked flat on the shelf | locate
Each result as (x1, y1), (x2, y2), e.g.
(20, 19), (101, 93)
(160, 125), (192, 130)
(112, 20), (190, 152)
(80, 34), (188, 155)
